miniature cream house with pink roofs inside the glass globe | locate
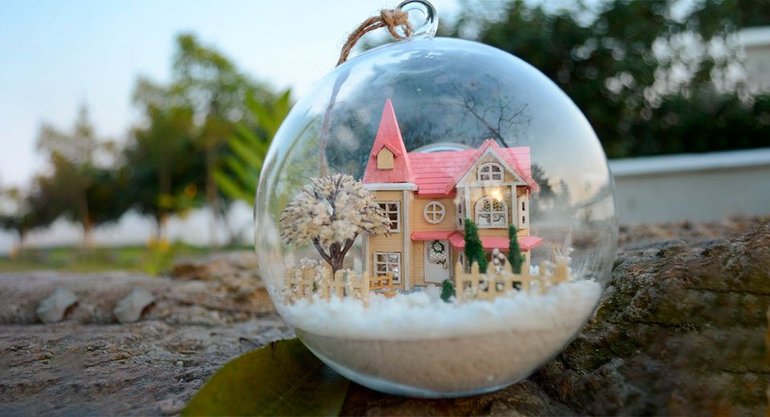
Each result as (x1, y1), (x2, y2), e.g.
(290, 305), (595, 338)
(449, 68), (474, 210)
(363, 100), (542, 289)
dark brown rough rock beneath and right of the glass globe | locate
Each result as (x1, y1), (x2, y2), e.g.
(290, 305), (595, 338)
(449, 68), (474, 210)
(343, 219), (770, 416)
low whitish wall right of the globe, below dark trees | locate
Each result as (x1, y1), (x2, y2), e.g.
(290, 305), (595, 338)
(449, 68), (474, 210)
(610, 148), (770, 225)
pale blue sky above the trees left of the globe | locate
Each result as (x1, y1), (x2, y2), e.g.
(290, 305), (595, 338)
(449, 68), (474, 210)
(0, 0), (460, 186)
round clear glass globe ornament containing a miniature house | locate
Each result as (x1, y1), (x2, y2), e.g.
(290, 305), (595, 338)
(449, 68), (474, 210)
(255, 1), (617, 397)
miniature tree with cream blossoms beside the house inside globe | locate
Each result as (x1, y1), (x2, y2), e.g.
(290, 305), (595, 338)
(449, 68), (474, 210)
(280, 174), (390, 273)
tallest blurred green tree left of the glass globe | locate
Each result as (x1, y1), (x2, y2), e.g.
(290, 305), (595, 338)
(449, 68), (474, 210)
(127, 34), (277, 246)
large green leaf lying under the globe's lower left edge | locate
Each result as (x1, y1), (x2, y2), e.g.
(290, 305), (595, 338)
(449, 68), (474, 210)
(182, 339), (349, 416)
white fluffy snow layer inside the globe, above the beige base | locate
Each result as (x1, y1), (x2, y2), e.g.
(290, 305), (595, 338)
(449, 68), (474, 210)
(278, 280), (602, 340)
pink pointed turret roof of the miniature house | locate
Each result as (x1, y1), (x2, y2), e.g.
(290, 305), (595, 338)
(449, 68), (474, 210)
(363, 99), (414, 183)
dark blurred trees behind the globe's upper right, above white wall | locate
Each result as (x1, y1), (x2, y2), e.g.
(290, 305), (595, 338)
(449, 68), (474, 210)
(443, 0), (770, 157)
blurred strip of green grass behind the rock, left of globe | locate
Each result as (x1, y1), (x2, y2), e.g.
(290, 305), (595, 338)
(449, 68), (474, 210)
(0, 242), (245, 275)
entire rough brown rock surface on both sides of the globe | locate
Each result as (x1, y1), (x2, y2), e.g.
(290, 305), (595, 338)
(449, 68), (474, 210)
(0, 224), (770, 416)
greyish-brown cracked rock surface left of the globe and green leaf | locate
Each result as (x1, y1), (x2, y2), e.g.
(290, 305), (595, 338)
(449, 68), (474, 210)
(0, 253), (293, 416)
